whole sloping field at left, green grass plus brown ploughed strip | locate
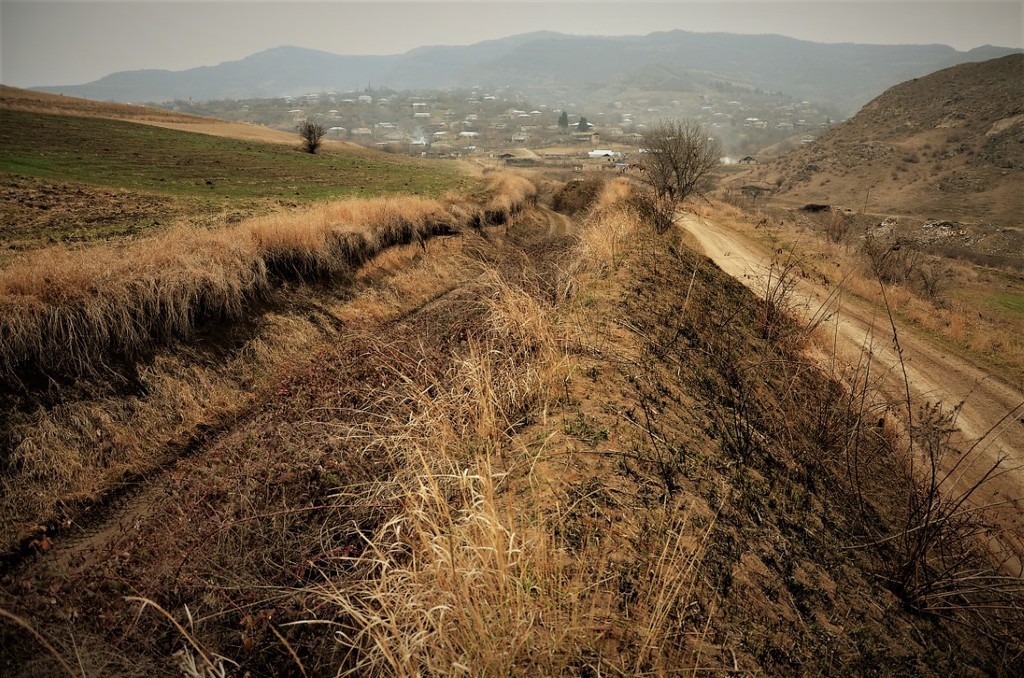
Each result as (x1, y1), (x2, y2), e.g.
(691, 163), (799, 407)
(0, 110), (476, 250)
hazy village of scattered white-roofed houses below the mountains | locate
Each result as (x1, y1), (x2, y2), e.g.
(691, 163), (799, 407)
(168, 82), (838, 171)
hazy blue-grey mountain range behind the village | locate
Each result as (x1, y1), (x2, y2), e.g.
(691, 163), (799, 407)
(39, 31), (1014, 116)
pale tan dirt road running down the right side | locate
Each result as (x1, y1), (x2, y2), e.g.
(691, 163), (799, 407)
(680, 214), (1024, 548)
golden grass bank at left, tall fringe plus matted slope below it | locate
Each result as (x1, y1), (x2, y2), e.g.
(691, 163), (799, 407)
(0, 174), (528, 546)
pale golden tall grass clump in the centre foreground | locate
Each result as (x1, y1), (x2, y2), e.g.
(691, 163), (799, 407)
(311, 271), (580, 675)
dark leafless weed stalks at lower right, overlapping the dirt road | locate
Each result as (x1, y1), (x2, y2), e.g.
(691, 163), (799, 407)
(823, 281), (1024, 650)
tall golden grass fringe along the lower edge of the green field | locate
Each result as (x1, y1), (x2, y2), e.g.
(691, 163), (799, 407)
(0, 180), (536, 393)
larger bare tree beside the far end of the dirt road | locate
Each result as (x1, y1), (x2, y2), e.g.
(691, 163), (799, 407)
(639, 120), (722, 230)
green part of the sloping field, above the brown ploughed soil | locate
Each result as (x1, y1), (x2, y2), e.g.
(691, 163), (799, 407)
(0, 110), (469, 203)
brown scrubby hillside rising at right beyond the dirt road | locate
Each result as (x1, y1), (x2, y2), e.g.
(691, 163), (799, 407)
(737, 54), (1024, 225)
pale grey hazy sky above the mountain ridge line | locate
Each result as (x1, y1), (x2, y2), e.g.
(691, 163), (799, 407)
(0, 0), (1024, 87)
